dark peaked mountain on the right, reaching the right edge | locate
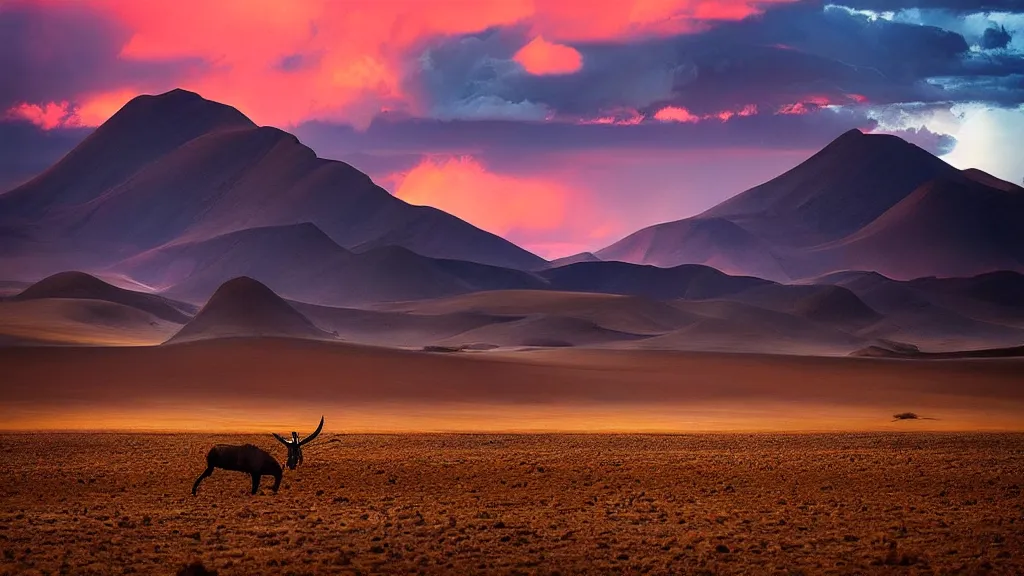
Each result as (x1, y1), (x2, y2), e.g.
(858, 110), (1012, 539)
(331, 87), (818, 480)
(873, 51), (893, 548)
(596, 130), (1024, 282)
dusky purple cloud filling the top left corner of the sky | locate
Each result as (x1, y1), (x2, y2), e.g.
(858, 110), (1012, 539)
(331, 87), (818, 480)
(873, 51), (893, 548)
(0, 0), (202, 109)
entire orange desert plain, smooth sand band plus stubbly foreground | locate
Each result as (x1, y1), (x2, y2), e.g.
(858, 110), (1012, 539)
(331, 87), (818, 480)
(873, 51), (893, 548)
(0, 338), (1024, 575)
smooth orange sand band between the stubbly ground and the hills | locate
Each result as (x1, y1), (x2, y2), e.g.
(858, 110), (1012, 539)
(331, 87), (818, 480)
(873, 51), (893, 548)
(0, 338), (1024, 430)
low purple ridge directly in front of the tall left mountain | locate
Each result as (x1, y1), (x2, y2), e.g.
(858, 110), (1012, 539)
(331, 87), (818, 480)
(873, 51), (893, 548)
(113, 222), (546, 306)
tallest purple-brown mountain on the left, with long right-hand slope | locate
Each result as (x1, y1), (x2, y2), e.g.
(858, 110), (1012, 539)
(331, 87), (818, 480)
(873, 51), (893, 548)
(0, 90), (544, 270)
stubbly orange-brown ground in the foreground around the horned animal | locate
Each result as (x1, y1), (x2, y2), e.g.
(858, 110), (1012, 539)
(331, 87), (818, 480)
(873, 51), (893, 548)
(0, 433), (1024, 576)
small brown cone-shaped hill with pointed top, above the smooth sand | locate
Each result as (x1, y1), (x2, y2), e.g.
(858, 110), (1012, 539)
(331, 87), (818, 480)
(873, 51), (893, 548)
(167, 277), (333, 343)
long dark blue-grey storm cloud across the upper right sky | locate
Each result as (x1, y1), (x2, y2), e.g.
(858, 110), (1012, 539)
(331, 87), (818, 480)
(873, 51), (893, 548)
(408, 1), (1024, 117)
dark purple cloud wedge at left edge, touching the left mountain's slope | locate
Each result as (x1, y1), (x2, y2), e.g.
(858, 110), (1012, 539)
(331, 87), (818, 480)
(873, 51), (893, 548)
(0, 120), (92, 194)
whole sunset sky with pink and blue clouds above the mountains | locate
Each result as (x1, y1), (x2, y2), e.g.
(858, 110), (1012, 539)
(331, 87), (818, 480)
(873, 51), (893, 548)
(0, 0), (1024, 257)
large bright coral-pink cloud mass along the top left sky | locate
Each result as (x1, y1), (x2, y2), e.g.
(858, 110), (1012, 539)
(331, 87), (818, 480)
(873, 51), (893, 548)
(9, 0), (791, 127)
